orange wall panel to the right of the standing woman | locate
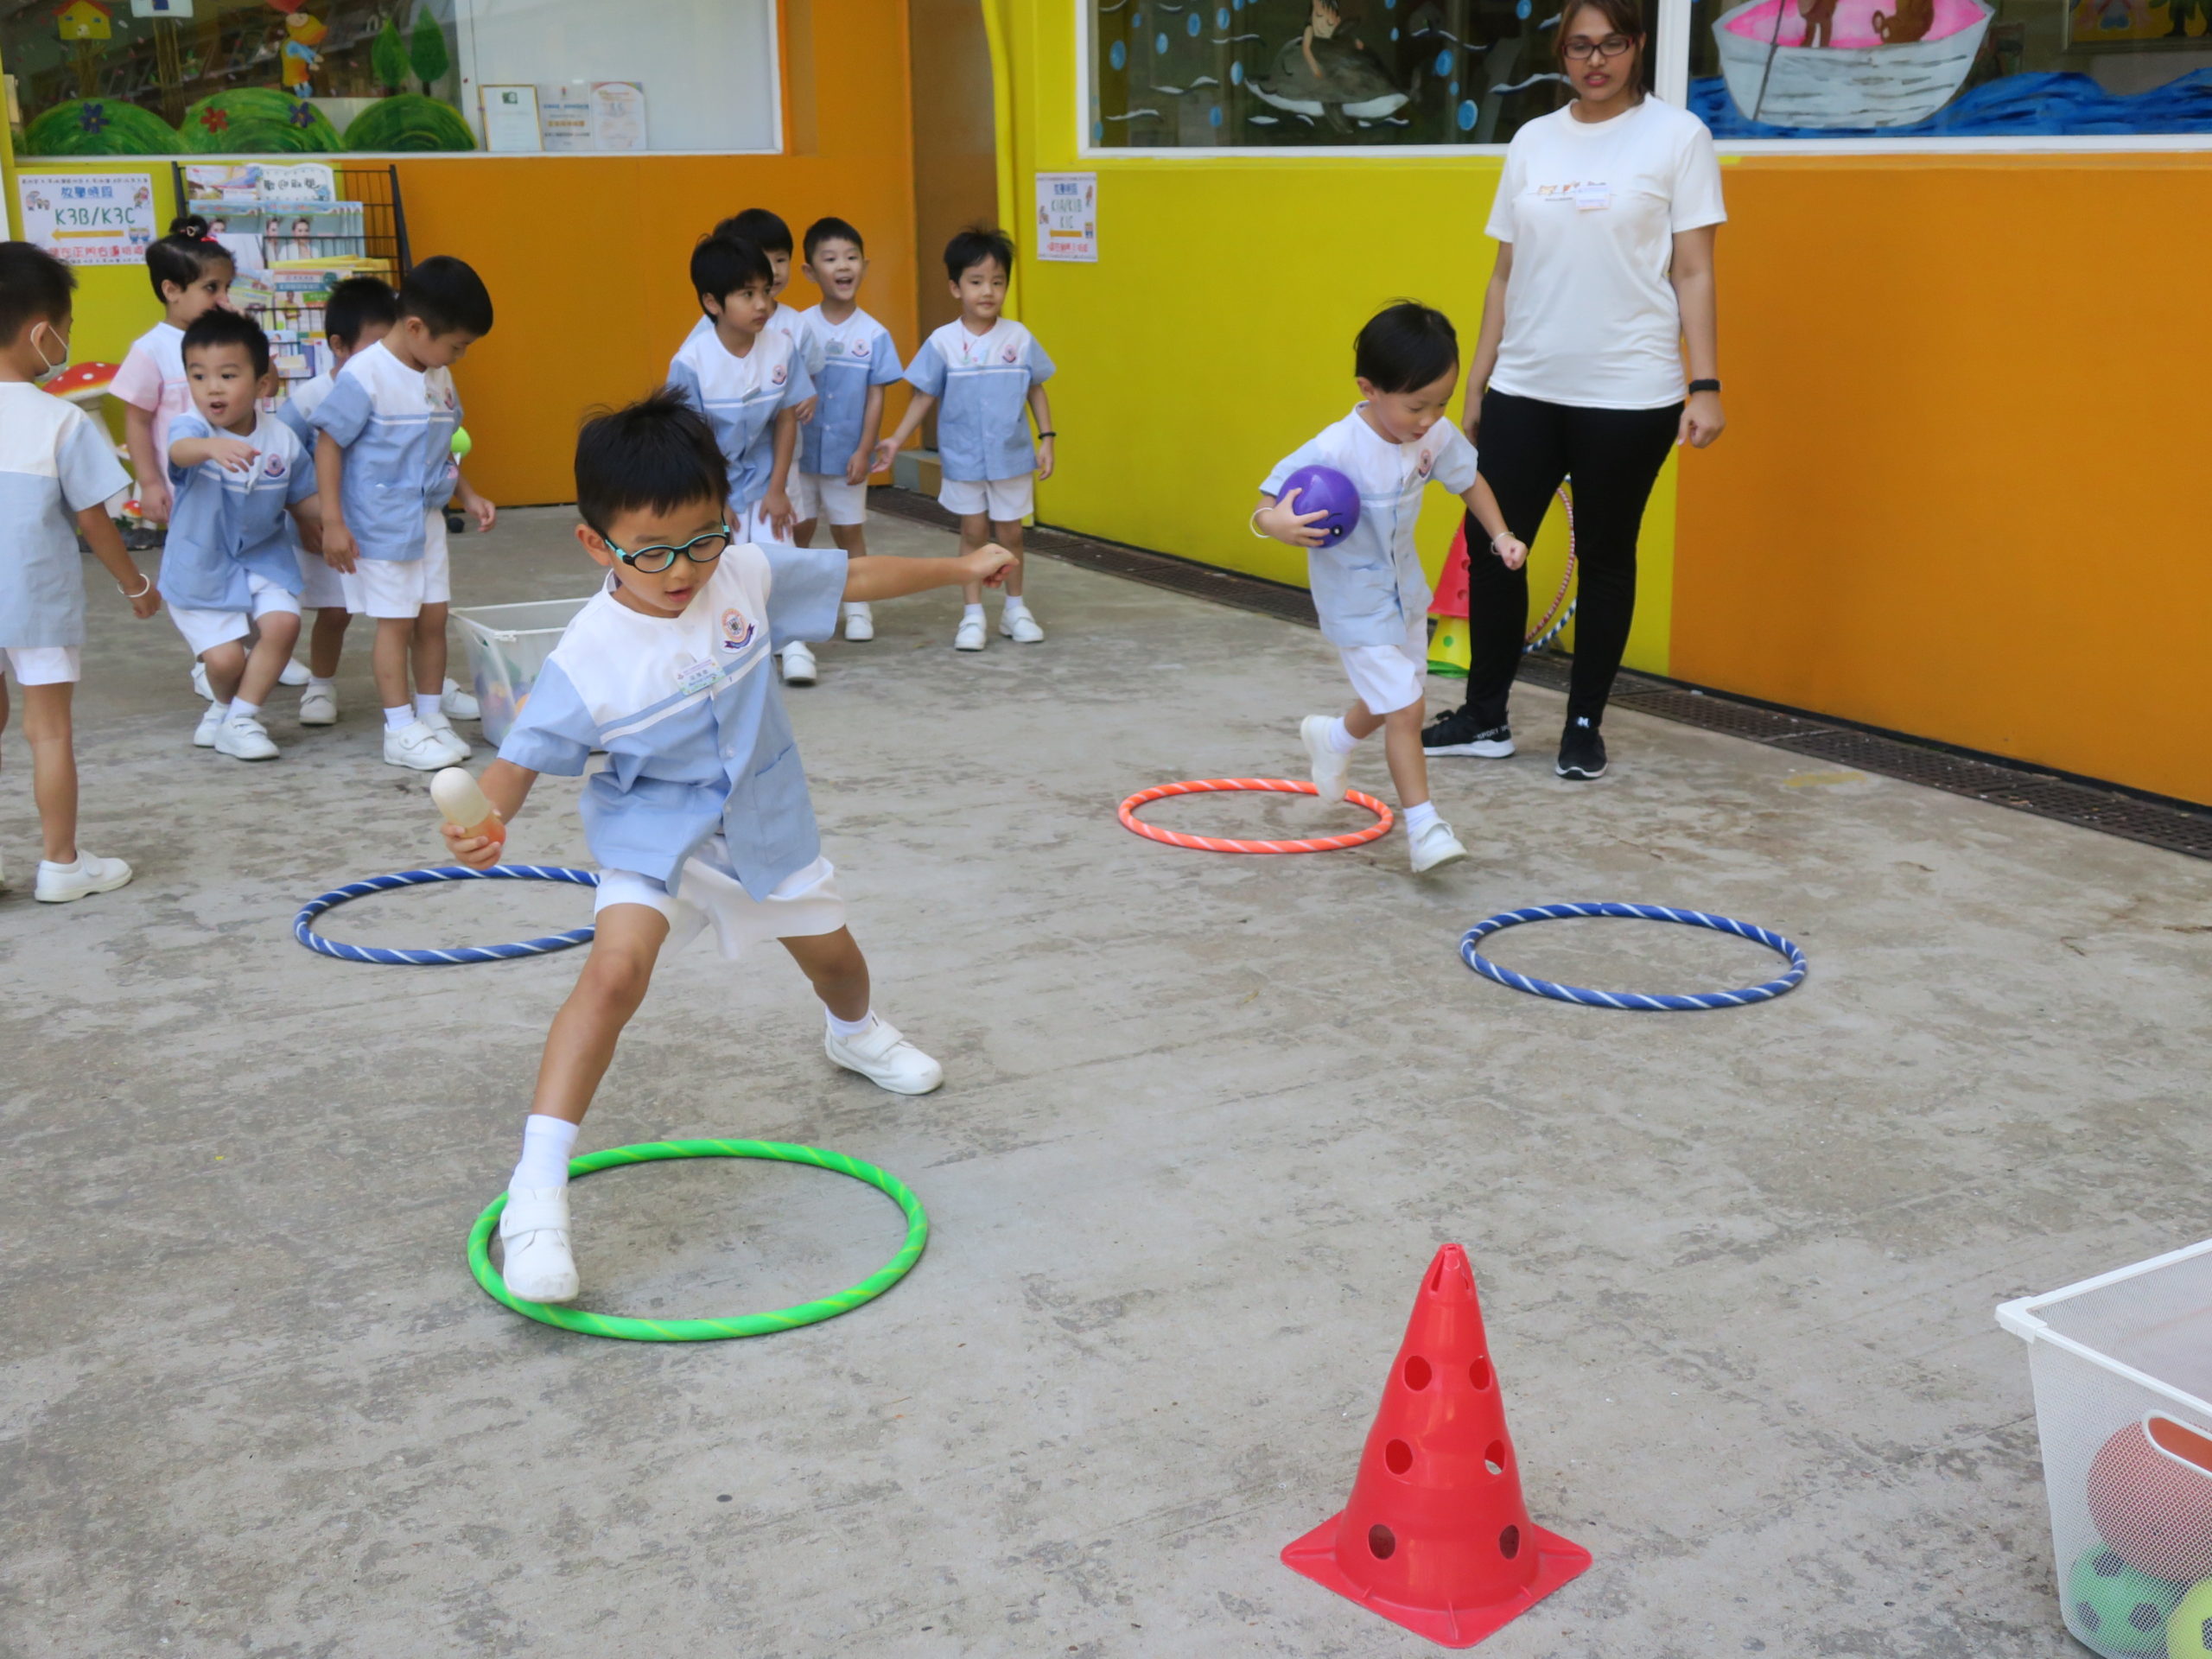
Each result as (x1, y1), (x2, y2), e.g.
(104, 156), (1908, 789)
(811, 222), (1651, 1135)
(1672, 155), (2212, 803)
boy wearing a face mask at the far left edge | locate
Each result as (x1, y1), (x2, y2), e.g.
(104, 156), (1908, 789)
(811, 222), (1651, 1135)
(0, 241), (162, 905)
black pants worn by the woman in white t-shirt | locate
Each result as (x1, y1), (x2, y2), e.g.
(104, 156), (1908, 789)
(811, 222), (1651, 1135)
(1466, 391), (1681, 728)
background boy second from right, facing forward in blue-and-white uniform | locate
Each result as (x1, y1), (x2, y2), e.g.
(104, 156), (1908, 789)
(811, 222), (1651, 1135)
(783, 219), (898, 654)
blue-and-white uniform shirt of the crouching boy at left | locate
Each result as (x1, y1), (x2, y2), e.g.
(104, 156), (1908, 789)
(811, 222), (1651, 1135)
(162, 410), (315, 611)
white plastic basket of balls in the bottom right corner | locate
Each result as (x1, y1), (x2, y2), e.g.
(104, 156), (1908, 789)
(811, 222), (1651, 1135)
(1998, 1239), (2212, 1659)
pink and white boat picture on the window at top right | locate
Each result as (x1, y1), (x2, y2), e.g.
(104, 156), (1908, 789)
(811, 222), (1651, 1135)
(1712, 0), (1995, 126)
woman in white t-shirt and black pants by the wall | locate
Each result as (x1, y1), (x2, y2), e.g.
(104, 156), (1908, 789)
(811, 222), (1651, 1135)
(1422, 0), (1727, 779)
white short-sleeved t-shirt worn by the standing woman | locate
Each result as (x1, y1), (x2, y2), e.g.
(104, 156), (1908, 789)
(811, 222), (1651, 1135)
(1489, 98), (1727, 410)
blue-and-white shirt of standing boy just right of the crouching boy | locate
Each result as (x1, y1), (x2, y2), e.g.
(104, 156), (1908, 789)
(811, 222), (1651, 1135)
(308, 340), (460, 564)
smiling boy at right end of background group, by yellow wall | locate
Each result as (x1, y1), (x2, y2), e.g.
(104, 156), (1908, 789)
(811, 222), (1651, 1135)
(872, 230), (1055, 651)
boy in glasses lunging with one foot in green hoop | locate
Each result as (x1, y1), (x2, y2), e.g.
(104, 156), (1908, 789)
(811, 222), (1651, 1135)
(445, 387), (1013, 1303)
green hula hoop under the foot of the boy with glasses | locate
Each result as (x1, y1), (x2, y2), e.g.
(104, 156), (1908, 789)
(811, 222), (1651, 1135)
(469, 1141), (929, 1343)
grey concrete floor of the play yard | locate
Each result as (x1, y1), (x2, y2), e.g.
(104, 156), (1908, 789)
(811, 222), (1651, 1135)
(0, 511), (2212, 1659)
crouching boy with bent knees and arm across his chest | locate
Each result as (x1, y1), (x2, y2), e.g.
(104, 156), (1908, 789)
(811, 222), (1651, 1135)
(162, 309), (321, 761)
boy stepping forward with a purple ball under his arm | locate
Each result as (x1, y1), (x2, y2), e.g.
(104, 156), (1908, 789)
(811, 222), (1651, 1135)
(1252, 301), (1529, 874)
